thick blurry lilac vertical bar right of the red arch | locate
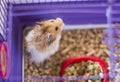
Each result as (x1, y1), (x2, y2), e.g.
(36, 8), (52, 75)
(106, 0), (115, 82)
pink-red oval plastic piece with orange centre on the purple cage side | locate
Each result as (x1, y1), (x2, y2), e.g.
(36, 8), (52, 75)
(0, 41), (10, 79)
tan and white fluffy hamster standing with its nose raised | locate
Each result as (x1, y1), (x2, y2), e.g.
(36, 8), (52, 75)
(25, 18), (64, 63)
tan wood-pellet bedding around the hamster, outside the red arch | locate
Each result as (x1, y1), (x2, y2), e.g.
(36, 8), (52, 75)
(24, 29), (109, 82)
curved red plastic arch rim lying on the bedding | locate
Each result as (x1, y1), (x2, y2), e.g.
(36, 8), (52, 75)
(60, 56), (108, 82)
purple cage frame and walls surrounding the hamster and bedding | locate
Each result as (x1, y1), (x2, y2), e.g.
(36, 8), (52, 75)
(0, 0), (120, 82)
